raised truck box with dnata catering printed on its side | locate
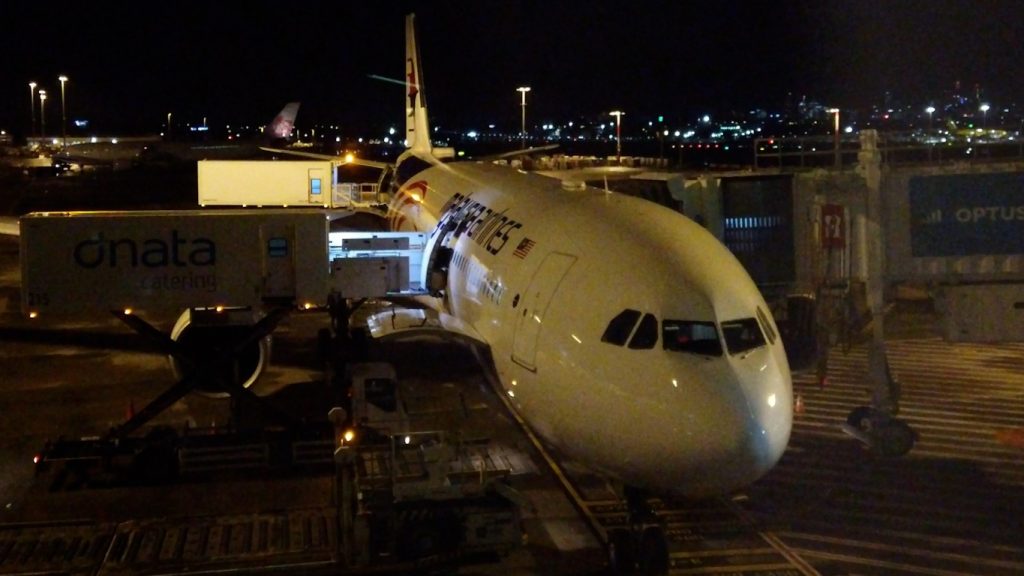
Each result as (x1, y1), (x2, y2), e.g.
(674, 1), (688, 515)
(20, 208), (330, 316)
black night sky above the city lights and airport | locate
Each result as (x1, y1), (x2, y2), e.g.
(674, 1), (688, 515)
(0, 0), (1024, 134)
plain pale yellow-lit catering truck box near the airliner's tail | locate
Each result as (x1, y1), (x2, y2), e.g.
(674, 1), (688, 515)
(197, 160), (339, 208)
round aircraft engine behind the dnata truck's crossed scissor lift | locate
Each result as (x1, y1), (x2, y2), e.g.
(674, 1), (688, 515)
(167, 308), (270, 398)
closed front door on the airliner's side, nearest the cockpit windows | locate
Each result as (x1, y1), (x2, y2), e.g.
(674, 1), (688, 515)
(512, 252), (577, 370)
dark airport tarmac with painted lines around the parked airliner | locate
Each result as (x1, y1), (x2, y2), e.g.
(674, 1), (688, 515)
(0, 163), (1024, 576)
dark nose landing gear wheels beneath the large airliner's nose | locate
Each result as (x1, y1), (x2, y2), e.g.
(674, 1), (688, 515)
(607, 487), (669, 576)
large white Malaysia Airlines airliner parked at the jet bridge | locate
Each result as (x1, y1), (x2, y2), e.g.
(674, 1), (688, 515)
(266, 14), (794, 568)
